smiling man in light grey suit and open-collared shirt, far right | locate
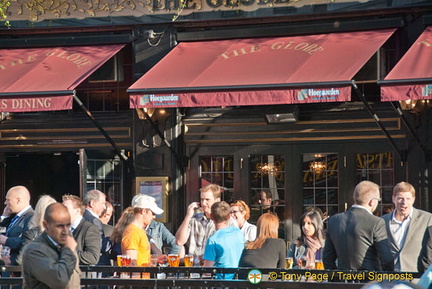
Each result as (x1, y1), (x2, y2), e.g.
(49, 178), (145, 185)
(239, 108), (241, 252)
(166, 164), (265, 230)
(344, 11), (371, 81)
(382, 182), (432, 272)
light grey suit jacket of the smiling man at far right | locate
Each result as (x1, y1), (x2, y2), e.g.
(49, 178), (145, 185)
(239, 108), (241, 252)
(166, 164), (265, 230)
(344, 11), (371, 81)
(382, 208), (432, 272)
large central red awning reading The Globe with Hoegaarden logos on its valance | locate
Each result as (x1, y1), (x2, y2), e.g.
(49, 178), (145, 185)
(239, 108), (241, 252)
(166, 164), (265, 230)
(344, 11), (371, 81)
(128, 29), (394, 108)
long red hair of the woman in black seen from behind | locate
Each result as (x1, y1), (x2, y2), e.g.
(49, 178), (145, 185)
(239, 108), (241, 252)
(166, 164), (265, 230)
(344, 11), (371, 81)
(246, 213), (279, 249)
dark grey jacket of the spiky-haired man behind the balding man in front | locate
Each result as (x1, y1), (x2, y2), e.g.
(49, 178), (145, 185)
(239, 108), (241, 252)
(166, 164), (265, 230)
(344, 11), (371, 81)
(72, 218), (101, 265)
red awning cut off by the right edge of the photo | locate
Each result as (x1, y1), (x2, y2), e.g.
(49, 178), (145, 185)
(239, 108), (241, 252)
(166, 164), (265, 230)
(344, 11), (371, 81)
(379, 27), (432, 101)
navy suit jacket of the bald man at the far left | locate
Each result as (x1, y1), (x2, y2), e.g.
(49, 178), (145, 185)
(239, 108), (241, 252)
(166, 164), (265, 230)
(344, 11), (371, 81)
(5, 208), (34, 265)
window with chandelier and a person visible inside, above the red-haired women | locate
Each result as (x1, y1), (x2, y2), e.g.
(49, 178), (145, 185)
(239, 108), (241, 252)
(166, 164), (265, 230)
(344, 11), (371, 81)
(250, 155), (286, 222)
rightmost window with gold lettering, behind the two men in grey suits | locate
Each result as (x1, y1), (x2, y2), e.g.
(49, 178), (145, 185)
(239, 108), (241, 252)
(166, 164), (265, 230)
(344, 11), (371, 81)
(356, 152), (394, 215)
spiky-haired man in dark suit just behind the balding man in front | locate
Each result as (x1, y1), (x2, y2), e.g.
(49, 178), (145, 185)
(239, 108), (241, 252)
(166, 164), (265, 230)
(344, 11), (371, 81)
(63, 195), (101, 265)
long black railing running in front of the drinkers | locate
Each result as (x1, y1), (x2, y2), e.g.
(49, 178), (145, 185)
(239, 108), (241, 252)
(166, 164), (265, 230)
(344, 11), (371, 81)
(0, 266), (420, 289)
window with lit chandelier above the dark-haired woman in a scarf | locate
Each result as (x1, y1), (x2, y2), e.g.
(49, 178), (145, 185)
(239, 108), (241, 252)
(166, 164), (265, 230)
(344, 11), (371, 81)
(303, 153), (339, 216)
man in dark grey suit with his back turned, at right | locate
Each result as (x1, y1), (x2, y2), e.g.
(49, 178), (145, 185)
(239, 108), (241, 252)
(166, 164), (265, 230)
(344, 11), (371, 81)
(323, 181), (393, 271)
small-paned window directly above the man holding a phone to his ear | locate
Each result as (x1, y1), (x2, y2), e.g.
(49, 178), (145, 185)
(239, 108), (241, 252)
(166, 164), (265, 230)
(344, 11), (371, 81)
(200, 156), (234, 203)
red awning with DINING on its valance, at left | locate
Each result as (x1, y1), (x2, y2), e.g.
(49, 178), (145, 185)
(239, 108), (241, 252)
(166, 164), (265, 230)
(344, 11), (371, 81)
(0, 44), (124, 112)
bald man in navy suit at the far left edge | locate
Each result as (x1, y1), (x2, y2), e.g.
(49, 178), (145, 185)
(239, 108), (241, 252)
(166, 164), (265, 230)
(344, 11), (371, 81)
(0, 186), (33, 265)
